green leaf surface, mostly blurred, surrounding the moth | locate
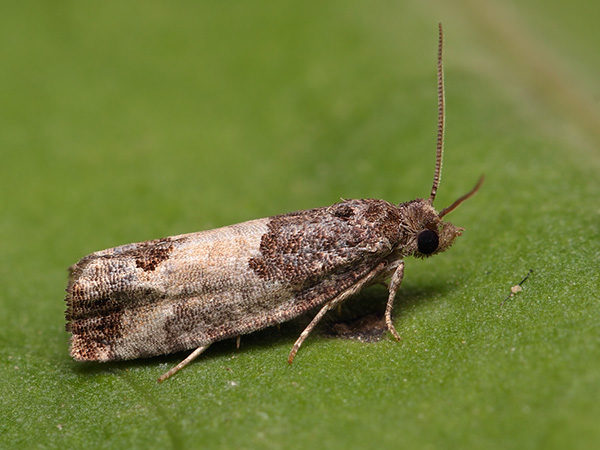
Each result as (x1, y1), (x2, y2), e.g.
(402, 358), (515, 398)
(0, 0), (600, 449)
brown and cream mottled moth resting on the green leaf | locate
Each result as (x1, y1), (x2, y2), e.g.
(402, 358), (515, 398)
(66, 24), (483, 381)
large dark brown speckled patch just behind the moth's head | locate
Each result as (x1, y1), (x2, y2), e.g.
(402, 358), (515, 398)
(249, 199), (400, 284)
